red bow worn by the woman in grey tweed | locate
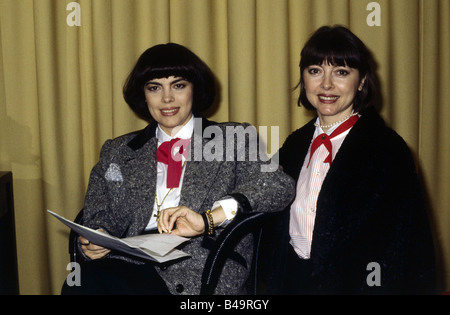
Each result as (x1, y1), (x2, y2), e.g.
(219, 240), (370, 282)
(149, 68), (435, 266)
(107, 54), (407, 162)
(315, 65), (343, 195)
(156, 138), (191, 188)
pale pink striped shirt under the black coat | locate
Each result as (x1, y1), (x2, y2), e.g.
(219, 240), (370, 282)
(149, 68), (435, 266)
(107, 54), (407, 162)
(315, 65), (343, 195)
(289, 118), (351, 259)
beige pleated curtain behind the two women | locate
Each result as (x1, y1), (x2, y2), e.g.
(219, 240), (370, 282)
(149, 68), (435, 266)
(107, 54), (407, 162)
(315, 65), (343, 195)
(0, 0), (450, 294)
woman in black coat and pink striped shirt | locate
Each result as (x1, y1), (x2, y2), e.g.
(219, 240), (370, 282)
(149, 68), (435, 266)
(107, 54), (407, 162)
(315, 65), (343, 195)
(276, 26), (435, 294)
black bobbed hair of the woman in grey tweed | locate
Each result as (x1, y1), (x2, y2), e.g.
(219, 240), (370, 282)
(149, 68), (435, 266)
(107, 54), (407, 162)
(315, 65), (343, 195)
(123, 43), (216, 121)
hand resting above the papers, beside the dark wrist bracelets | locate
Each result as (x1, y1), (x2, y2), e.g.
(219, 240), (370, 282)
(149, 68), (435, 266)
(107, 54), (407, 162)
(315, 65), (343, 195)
(158, 206), (205, 237)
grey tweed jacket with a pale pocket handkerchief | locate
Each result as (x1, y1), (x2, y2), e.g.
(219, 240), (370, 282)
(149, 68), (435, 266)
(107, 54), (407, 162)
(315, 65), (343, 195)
(83, 118), (295, 294)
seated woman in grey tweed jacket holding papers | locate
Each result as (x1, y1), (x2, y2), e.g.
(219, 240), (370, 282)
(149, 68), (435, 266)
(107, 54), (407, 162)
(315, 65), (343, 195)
(62, 43), (295, 295)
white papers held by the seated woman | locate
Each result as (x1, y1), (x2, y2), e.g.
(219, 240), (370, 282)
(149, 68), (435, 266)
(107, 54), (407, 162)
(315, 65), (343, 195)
(47, 210), (189, 263)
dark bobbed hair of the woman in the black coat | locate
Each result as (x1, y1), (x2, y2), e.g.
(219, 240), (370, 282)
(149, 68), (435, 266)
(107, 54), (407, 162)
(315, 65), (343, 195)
(297, 25), (375, 113)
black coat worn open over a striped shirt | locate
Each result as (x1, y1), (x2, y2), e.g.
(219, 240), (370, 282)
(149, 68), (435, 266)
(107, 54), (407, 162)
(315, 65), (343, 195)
(275, 110), (435, 294)
